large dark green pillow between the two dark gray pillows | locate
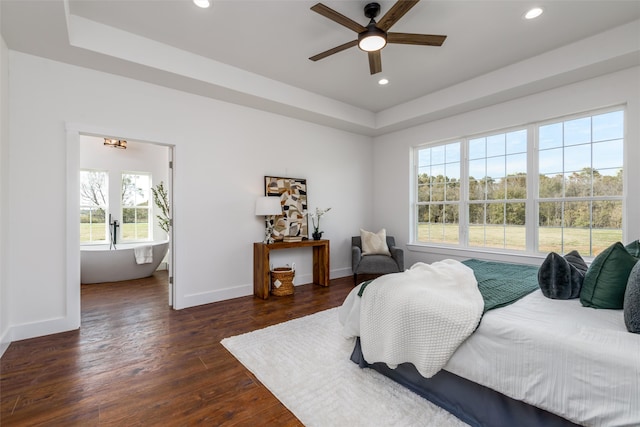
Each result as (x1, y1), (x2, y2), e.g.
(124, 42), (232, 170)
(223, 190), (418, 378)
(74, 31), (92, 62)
(580, 242), (638, 309)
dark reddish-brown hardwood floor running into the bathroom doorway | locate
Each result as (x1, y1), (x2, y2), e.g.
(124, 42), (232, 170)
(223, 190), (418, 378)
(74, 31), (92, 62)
(0, 272), (353, 427)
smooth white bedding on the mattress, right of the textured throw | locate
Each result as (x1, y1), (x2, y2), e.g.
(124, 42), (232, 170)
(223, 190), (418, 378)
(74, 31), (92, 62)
(444, 290), (640, 427)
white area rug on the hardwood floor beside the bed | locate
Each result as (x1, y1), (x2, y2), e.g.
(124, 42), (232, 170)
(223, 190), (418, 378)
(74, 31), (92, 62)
(221, 308), (467, 427)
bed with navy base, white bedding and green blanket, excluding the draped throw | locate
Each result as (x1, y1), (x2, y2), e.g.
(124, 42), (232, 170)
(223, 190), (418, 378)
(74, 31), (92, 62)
(345, 260), (640, 426)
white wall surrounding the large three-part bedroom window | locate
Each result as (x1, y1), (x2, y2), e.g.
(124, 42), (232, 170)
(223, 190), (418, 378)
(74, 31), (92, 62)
(374, 67), (640, 266)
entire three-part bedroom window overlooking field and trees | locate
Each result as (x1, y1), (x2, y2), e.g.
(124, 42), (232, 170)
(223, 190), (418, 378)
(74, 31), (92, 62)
(414, 109), (624, 256)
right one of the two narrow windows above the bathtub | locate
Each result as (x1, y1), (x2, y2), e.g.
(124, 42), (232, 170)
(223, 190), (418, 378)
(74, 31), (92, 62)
(120, 172), (152, 241)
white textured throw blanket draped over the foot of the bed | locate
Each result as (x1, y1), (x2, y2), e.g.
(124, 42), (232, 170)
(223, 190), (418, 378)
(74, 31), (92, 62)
(339, 260), (484, 378)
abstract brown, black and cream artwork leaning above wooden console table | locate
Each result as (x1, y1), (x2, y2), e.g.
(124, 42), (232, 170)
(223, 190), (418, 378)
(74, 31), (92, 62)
(264, 176), (309, 242)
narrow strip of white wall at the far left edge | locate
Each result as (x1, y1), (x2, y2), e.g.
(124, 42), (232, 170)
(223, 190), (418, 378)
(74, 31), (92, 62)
(0, 25), (11, 356)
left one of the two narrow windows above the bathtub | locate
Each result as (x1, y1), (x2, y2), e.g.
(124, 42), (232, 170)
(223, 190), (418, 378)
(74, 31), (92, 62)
(80, 169), (109, 243)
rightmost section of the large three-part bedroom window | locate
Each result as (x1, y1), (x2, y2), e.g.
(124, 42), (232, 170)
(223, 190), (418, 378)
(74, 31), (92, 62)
(538, 111), (624, 256)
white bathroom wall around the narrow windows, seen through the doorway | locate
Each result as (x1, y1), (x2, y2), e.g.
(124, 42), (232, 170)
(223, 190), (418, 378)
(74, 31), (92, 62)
(80, 135), (170, 246)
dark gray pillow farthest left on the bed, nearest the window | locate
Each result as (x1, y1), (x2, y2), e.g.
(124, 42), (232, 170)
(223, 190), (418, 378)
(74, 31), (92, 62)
(538, 251), (588, 299)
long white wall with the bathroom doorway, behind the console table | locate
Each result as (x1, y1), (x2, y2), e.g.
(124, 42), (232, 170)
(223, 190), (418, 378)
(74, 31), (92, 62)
(3, 51), (373, 339)
